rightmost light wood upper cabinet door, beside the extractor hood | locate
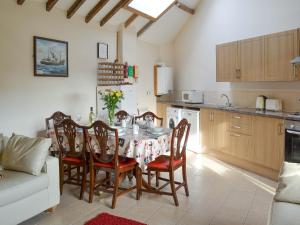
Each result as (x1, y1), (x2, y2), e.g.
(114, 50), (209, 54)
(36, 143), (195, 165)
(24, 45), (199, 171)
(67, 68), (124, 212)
(265, 30), (298, 81)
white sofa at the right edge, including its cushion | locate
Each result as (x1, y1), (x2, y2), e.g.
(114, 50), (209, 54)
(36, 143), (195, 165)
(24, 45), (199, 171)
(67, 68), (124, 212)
(268, 162), (300, 225)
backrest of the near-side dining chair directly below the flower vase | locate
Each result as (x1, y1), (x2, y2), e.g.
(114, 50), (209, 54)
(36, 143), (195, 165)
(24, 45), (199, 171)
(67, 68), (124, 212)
(85, 120), (119, 168)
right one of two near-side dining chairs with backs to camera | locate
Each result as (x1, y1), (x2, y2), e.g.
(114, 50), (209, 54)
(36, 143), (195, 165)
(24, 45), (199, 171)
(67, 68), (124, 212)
(85, 121), (141, 209)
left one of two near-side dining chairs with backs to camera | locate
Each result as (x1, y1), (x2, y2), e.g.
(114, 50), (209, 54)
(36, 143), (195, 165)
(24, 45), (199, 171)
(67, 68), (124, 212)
(54, 119), (87, 200)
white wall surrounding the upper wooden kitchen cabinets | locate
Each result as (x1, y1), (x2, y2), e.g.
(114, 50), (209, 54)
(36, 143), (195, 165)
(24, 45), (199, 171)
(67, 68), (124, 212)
(174, 0), (300, 91)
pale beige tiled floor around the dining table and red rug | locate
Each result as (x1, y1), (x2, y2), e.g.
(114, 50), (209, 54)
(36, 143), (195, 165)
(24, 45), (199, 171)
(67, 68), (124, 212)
(22, 153), (276, 225)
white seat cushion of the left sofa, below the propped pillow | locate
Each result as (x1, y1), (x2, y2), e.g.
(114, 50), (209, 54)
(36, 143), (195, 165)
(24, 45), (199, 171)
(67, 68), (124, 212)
(0, 170), (49, 207)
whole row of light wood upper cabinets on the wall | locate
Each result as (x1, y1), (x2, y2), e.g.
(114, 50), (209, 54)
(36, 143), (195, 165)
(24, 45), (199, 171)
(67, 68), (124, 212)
(216, 29), (300, 82)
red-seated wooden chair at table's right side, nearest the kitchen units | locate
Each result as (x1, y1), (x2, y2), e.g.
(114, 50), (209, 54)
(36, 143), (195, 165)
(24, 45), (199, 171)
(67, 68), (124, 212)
(143, 119), (191, 206)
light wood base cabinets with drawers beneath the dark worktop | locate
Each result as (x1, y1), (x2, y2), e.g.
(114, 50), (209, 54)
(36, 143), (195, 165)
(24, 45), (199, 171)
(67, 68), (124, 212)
(201, 109), (284, 179)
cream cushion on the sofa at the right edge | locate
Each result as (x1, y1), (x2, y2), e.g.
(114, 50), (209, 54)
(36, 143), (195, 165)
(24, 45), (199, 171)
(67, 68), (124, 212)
(274, 162), (300, 204)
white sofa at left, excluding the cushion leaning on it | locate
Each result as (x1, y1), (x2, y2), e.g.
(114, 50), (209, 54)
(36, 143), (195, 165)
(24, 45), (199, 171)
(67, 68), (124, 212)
(0, 138), (60, 225)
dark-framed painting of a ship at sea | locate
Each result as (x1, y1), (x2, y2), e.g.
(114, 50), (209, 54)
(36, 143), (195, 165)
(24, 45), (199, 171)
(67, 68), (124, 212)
(33, 36), (69, 77)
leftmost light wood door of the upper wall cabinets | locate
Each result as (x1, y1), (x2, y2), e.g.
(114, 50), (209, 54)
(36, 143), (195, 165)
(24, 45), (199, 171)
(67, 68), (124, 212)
(216, 41), (240, 82)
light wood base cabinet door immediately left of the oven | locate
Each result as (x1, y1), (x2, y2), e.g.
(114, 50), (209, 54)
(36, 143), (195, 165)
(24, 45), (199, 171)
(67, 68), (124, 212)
(253, 116), (284, 170)
